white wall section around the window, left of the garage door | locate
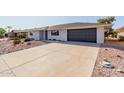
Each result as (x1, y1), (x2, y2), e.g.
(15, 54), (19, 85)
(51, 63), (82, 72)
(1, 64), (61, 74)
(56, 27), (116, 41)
(48, 30), (67, 41)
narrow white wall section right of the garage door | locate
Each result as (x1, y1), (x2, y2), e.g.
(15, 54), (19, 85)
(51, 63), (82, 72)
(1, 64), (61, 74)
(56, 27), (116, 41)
(97, 27), (104, 43)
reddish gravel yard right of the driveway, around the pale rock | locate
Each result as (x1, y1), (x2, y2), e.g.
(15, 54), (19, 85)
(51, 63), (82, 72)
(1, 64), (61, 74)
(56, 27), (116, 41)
(92, 41), (124, 77)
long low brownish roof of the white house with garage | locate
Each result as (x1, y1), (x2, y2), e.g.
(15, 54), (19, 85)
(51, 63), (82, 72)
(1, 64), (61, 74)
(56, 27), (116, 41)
(13, 22), (112, 32)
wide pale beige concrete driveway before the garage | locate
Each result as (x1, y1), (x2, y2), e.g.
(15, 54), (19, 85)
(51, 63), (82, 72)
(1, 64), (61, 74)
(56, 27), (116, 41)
(0, 42), (99, 77)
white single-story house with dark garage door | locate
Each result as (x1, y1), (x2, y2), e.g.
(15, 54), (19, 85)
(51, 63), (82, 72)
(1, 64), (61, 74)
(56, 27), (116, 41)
(13, 22), (111, 43)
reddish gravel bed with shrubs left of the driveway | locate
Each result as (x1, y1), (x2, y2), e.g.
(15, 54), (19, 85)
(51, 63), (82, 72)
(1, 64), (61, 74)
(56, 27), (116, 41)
(0, 40), (47, 55)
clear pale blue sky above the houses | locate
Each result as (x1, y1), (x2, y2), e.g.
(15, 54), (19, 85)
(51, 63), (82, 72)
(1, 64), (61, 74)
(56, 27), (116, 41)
(0, 16), (124, 29)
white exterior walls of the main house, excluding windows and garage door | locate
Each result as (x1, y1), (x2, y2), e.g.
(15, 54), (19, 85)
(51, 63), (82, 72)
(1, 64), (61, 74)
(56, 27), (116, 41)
(28, 27), (104, 43)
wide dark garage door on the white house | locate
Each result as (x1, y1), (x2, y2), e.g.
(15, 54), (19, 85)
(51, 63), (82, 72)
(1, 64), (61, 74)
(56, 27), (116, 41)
(67, 28), (96, 43)
